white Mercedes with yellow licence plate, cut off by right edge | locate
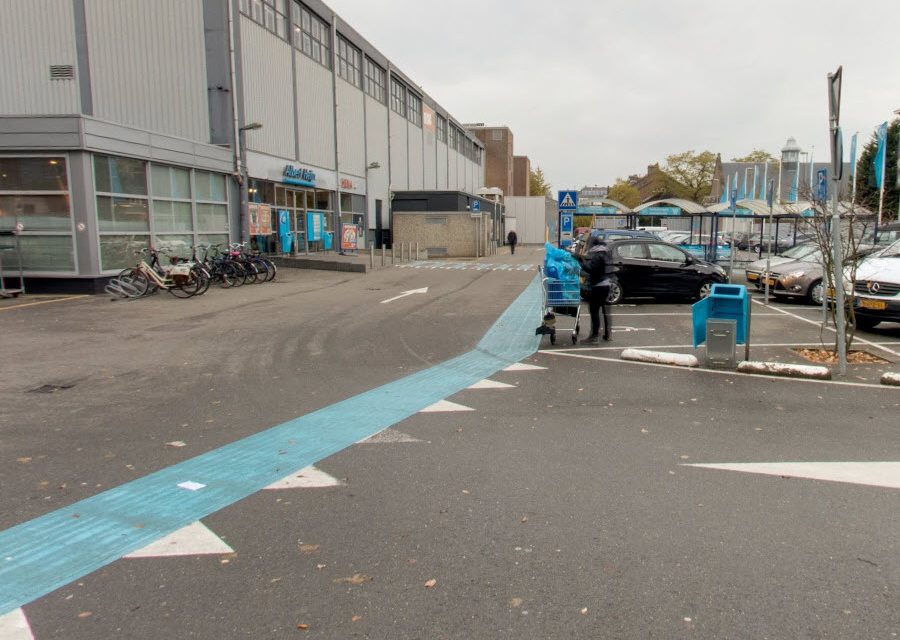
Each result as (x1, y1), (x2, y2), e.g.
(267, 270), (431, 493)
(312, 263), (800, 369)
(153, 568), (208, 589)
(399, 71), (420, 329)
(854, 240), (900, 329)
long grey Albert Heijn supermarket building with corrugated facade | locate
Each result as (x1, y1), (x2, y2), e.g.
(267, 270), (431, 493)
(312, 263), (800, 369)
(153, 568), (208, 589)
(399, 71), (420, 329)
(0, 0), (485, 288)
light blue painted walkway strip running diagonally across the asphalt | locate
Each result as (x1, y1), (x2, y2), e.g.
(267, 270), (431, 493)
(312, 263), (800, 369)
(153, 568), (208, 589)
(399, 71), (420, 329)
(0, 279), (542, 615)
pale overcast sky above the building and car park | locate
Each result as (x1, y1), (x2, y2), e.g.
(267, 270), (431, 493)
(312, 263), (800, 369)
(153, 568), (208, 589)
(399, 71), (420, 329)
(326, 0), (900, 189)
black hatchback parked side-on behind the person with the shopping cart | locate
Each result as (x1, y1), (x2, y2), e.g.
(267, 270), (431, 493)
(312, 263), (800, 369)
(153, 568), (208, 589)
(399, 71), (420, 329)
(596, 238), (728, 304)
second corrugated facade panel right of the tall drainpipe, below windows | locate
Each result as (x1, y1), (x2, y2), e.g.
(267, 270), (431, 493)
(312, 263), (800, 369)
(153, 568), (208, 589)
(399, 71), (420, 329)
(298, 56), (336, 169)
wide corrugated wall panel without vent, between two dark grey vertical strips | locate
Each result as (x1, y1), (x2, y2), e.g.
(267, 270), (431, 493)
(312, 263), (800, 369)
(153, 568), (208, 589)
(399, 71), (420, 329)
(86, 0), (209, 142)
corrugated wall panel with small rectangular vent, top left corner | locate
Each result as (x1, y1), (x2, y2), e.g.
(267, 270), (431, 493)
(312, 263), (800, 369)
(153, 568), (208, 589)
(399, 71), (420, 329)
(0, 0), (81, 115)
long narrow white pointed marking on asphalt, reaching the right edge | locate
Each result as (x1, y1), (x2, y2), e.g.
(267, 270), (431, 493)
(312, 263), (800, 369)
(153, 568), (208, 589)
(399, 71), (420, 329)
(686, 462), (900, 489)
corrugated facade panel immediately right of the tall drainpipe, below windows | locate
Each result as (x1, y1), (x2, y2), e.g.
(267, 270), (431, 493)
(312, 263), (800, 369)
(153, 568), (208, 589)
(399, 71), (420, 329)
(241, 17), (294, 158)
